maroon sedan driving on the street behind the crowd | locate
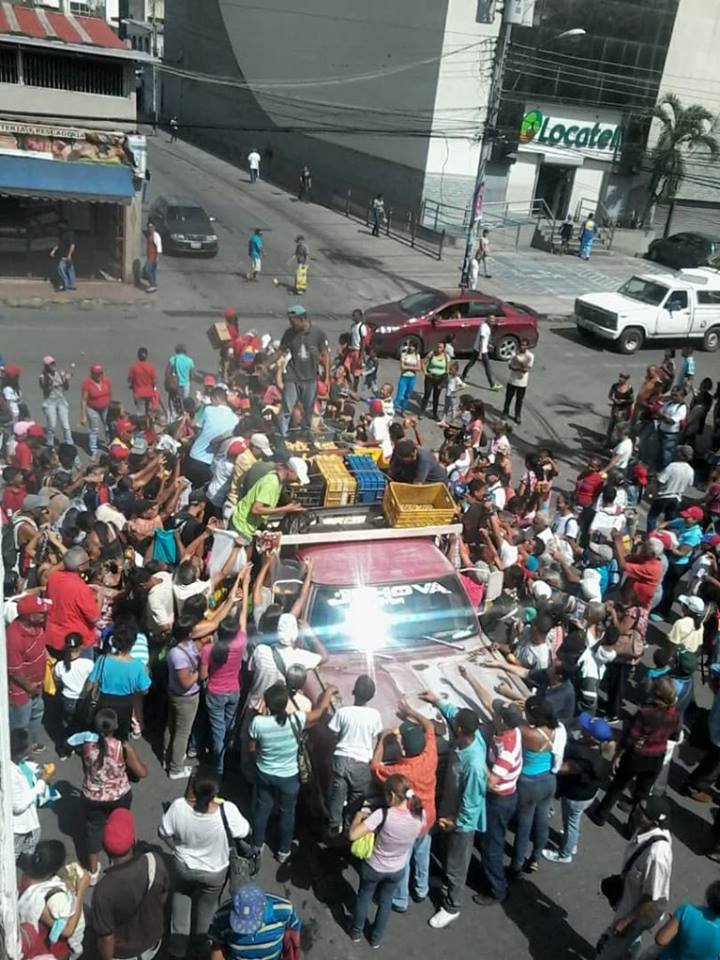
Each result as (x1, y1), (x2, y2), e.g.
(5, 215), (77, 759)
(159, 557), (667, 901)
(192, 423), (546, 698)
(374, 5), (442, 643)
(365, 290), (538, 360)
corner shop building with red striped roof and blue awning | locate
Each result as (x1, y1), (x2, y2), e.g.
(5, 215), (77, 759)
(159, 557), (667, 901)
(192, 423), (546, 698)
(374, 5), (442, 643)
(0, 3), (152, 280)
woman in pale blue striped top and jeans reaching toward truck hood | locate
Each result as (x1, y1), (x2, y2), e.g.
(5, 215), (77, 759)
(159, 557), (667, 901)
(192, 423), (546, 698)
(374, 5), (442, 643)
(248, 683), (337, 863)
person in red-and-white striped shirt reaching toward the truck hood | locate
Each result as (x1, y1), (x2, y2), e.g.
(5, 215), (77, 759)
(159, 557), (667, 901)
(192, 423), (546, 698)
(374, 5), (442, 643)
(458, 666), (523, 907)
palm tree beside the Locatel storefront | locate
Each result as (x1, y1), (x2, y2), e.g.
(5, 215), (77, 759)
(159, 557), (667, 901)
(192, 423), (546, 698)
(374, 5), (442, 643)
(642, 93), (720, 224)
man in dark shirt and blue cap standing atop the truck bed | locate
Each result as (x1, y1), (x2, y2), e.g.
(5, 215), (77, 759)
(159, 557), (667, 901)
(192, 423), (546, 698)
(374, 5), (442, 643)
(277, 303), (330, 437)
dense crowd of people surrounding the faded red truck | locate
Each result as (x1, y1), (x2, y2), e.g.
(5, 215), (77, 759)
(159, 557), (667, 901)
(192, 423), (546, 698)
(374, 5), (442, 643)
(0, 305), (720, 960)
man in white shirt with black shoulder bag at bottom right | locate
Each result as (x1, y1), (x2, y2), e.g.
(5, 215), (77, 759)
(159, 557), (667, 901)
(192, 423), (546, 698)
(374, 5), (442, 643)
(596, 797), (672, 960)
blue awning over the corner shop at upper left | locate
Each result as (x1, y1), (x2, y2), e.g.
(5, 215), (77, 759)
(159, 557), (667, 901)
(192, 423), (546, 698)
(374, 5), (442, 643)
(0, 156), (135, 203)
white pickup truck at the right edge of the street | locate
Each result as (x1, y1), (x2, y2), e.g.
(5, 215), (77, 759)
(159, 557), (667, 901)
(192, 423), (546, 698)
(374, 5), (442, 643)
(575, 267), (720, 353)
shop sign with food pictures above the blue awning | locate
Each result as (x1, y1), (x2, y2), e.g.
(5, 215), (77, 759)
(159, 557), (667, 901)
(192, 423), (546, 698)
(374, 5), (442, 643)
(0, 121), (133, 166)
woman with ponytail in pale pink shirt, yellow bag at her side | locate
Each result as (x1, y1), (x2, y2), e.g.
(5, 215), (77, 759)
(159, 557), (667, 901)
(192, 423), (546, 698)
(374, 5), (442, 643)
(350, 773), (425, 947)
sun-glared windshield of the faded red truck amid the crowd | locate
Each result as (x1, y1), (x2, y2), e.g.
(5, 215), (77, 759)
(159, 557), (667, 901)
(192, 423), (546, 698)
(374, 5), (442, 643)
(308, 576), (477, 653)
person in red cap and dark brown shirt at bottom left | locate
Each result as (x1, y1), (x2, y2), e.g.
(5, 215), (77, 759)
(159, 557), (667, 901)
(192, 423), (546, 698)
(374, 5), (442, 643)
(90, 807), (170, 960)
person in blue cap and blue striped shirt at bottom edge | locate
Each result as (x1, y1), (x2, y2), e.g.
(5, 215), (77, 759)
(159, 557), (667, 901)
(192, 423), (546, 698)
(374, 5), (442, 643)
(208, 883), (302, 960)
